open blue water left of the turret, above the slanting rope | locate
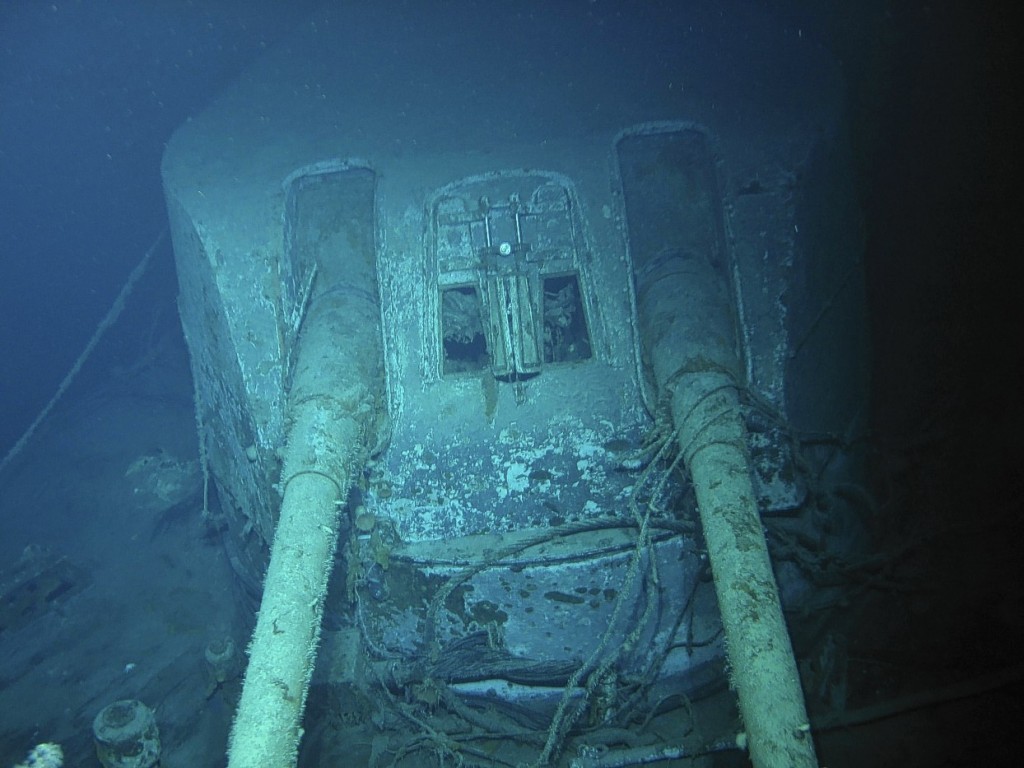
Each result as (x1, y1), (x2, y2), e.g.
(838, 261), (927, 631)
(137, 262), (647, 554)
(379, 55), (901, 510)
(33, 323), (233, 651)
(0, 0), (312, 452)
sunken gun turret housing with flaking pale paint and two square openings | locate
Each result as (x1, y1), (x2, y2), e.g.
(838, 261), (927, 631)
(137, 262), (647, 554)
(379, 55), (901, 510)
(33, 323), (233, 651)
(163, 4), (866, 765)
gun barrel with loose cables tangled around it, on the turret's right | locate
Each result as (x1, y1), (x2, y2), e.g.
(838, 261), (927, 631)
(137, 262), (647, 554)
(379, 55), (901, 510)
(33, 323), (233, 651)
(635, 248), (817, 768)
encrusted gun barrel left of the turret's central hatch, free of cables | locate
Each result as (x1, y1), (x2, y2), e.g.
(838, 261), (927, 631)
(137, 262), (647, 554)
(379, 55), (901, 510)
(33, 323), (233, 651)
(228, 183), (384, 768)
